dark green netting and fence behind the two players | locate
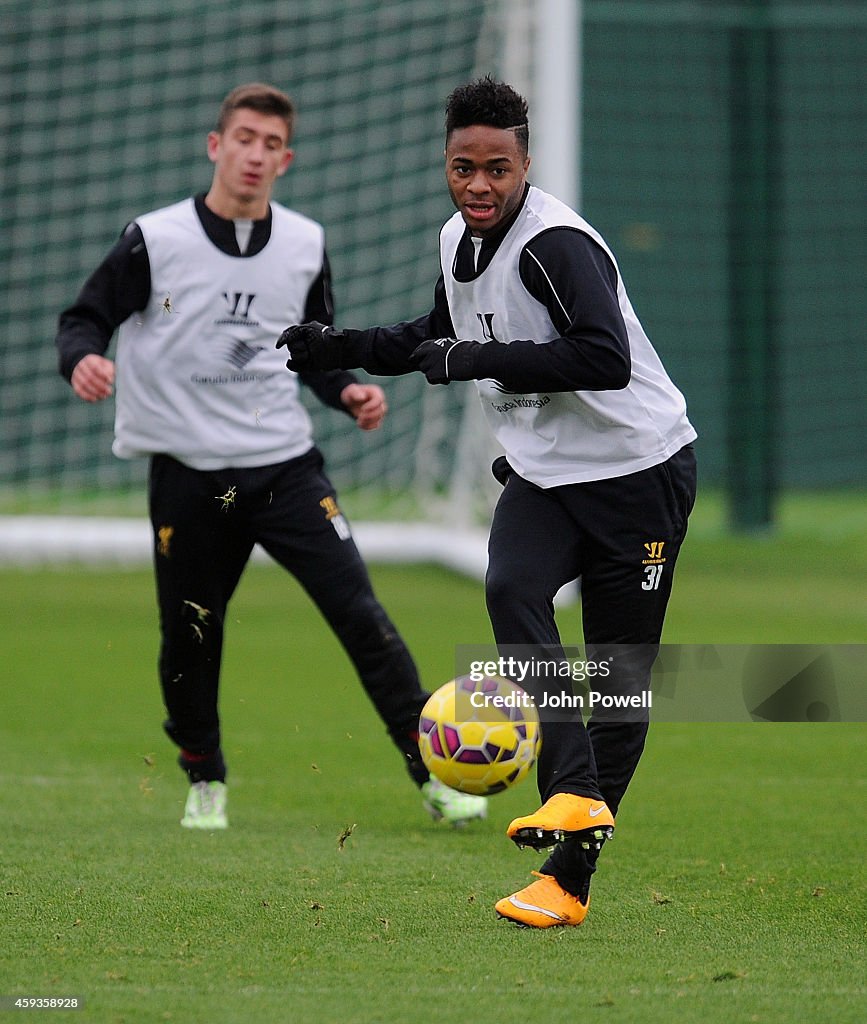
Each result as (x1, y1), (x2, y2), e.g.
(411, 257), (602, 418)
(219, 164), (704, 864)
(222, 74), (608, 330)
(0, 0), (867, 520)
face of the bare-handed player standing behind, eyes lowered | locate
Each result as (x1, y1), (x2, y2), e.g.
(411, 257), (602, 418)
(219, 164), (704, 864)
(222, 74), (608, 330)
(208, 108), (293, 219)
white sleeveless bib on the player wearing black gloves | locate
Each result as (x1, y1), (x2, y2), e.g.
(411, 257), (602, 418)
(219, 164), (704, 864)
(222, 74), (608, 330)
(440, 187), (696, 487)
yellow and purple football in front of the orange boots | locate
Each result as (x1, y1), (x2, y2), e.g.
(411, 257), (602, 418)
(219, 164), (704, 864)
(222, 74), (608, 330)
(419, 676), (541, 797)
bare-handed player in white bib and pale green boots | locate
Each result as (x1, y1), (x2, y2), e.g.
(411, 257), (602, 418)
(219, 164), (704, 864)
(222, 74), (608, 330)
(56, 83), (485, 829)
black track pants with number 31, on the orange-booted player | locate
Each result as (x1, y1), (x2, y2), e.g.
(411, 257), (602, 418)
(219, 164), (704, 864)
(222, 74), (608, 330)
(485, 444), (696, 888)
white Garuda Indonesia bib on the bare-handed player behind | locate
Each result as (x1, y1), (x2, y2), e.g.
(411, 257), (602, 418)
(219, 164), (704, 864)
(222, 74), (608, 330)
(113, 199), (324, 469)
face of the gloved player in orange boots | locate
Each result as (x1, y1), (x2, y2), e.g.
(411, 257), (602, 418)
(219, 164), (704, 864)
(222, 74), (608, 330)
(445, 125), (530, 237)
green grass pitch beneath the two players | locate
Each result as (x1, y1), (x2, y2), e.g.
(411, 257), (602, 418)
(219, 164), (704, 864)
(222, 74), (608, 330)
(0, 491), (867, 1024)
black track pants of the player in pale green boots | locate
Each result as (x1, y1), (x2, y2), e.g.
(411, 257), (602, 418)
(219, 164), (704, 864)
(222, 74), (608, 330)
(149, 450), (427, 779)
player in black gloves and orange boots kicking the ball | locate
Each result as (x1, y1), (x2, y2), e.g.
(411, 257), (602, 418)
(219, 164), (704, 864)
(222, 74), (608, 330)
(277, 78), (696, 928)
